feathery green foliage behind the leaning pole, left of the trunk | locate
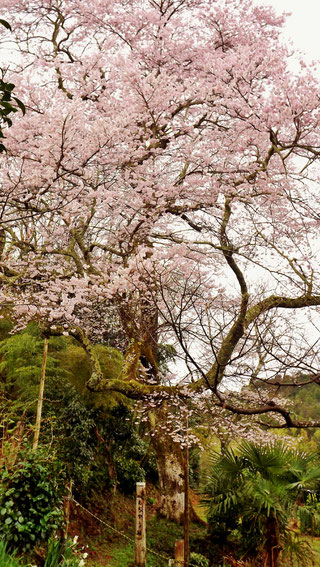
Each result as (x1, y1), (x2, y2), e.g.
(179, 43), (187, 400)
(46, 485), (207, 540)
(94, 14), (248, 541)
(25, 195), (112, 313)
(0, 319), (157, 498)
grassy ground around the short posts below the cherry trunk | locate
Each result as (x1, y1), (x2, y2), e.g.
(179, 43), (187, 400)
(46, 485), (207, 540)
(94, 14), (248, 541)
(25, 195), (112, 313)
(39, 494), (320, 567)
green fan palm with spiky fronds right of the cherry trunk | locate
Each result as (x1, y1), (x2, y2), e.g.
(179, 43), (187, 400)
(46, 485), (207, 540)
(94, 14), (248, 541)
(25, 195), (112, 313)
(205, 442), (320, 565)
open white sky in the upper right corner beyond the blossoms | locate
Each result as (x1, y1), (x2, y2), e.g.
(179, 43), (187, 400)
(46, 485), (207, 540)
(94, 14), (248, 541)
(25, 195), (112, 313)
(255, 0), (320, 61)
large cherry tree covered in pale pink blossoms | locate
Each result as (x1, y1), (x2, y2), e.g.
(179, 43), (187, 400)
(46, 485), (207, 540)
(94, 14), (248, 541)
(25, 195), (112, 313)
(0, 0), (320, 518)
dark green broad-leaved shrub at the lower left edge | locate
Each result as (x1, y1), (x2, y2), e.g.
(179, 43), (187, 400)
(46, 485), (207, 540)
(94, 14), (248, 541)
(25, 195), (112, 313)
(0, 451), (64, 551)
